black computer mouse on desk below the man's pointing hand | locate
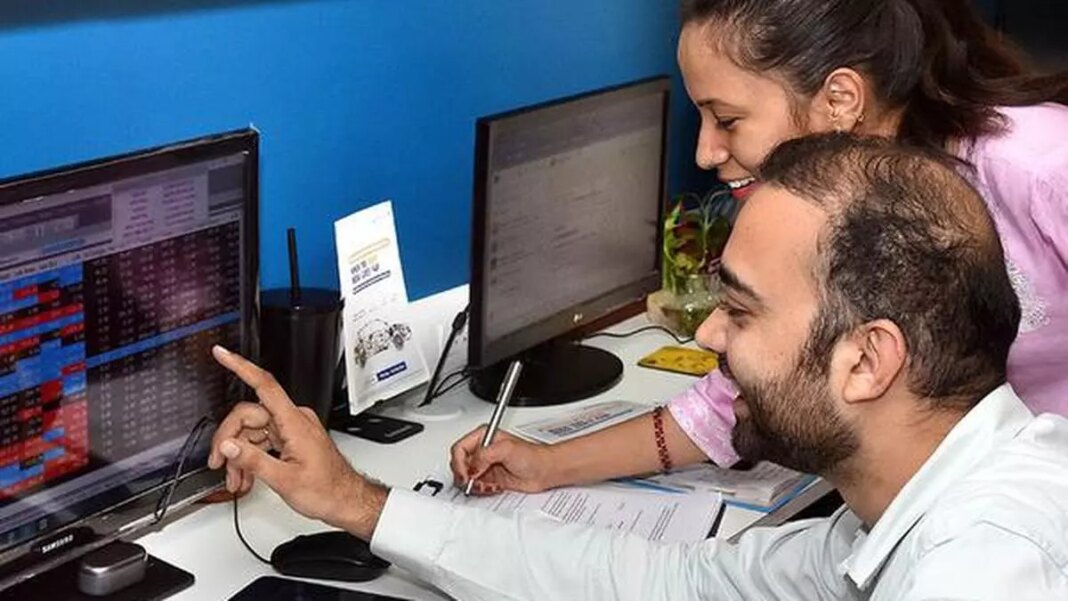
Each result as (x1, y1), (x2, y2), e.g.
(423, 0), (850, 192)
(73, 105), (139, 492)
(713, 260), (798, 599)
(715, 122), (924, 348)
(270, 531), (390, 582)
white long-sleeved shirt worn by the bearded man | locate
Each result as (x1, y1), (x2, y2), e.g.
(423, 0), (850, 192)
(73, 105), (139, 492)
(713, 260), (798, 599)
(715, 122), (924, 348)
(372, 384), (1068, 601)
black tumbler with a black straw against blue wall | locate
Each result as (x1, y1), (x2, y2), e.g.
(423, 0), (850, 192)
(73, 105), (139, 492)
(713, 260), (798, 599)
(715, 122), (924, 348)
(260, 227), (342, 425)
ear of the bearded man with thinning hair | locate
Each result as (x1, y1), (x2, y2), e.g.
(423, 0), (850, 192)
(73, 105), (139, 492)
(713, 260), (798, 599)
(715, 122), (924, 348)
(841, 319), (909, 404)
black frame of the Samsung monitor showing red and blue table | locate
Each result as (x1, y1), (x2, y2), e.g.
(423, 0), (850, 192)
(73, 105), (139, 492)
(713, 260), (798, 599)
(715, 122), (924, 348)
(0, 127), (260, 590)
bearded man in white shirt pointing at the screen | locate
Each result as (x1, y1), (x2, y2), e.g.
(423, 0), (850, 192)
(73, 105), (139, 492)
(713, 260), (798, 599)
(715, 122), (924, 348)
(209, 135), (1068, 600)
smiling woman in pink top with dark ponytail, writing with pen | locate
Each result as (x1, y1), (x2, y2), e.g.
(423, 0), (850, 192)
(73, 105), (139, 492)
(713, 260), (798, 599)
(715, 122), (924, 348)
(452, 0), (1068, 492)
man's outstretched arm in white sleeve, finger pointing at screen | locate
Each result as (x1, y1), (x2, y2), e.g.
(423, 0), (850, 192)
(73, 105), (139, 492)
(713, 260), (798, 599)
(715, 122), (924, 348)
(208, 348), (851, 601)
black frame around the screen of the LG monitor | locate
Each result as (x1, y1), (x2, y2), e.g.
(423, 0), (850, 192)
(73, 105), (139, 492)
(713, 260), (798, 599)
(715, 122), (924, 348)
(468, 75), (672, 369)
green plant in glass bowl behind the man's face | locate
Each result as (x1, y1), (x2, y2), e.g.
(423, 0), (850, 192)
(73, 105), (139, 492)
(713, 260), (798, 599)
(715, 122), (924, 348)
(647, 188), (737, 336)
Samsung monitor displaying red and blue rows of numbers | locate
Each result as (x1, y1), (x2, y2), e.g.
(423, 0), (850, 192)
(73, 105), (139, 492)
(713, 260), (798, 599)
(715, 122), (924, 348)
(0, 130), (258, 591)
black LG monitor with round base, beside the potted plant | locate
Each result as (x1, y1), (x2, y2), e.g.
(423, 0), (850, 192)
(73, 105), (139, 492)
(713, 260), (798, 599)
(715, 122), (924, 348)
(468, 77), (671, 406)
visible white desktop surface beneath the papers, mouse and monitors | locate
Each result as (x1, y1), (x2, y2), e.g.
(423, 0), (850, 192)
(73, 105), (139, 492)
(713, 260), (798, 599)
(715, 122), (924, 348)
(138, 316), (829, 601)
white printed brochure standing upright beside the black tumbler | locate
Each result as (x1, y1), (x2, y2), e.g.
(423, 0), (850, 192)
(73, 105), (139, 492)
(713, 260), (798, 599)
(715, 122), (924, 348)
(334, 201), (427, 414)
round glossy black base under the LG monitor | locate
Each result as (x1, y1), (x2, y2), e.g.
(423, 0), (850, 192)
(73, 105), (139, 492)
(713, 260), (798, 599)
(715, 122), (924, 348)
(470, 341), (623, 407)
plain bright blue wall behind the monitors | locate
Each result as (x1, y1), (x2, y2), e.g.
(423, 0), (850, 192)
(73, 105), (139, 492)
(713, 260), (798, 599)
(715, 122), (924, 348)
(0, 0), (693, 298)
